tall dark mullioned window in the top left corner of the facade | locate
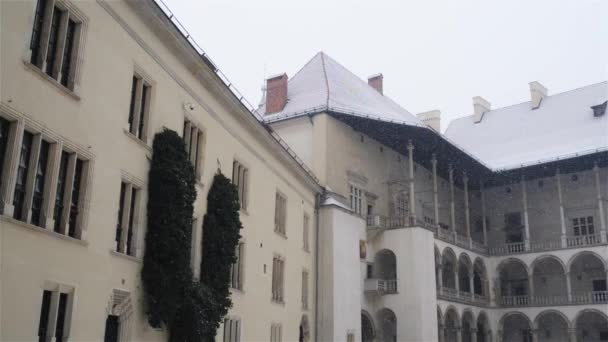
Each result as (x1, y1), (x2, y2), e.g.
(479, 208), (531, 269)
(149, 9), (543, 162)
(30, 0), (82, 89)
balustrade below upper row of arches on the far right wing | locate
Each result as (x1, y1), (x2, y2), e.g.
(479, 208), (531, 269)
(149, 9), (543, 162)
(498, 291), (608, 307)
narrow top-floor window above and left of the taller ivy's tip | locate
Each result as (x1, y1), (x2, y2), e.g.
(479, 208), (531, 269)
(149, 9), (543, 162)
(129, 74), (152, 142)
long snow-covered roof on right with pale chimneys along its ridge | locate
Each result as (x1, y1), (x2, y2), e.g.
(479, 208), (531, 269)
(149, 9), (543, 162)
(445, 82), (608, 171)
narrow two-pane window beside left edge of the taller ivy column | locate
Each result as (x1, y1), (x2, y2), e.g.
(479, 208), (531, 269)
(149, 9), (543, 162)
(116, 181), (140, 256)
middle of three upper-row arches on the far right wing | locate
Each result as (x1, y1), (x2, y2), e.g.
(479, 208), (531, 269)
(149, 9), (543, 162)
(530, 254), (568, 305)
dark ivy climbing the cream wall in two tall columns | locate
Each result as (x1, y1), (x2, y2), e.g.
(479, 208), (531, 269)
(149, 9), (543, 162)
(141, 129), (241, 342)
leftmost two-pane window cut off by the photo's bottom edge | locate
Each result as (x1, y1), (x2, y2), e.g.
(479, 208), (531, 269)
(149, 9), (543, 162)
(38, 290), (72, 342)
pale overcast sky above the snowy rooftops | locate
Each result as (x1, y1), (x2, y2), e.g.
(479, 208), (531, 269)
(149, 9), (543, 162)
(164, 0), (608, 129)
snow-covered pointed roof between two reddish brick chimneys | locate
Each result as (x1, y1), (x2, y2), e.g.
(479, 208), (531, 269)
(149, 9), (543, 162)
(258, 52), (426, 126)
